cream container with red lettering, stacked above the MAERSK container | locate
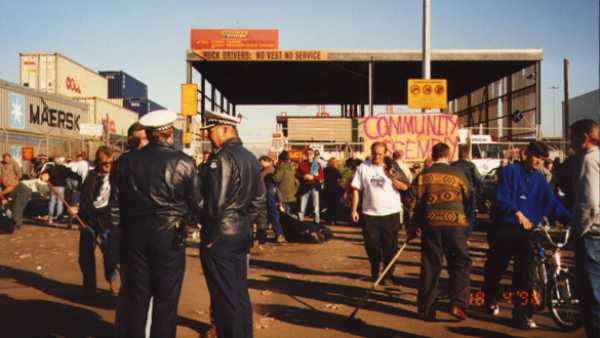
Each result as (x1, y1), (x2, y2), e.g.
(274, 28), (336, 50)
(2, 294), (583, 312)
(19, 53), (108, 98)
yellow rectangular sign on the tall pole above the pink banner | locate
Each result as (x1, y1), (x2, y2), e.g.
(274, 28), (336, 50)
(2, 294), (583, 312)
(408, 79), (448, 109)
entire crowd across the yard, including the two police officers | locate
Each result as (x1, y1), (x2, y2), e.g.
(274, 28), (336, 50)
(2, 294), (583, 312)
(0, 111), (600, 337)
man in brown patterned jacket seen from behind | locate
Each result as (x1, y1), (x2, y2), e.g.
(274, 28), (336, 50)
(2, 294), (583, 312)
(407, 143), (471, 321)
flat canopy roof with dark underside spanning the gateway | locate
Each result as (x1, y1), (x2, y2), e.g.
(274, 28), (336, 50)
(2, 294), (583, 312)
(187, 49), (543, 105)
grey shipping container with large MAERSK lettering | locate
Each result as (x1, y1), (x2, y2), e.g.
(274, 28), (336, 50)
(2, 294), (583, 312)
(0, 80), (89, 158)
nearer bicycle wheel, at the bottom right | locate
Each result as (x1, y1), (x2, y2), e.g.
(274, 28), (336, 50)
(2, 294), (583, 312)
(548, 272), (583, 331)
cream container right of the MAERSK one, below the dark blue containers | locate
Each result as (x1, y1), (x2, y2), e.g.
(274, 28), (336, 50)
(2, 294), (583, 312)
(75, 97), (139, 136)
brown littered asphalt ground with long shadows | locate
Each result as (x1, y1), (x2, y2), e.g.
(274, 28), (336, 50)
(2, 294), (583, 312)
(0, 220), (585, 338)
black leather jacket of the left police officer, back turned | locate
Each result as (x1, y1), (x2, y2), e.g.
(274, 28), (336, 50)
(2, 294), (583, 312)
(109, 142), (202, 228)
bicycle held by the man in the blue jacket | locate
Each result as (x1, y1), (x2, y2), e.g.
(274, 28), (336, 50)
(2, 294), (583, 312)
(532, 219), (583, 331)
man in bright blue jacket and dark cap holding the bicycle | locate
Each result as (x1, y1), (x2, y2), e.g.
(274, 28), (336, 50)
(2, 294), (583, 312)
(484, 141), (571, 329)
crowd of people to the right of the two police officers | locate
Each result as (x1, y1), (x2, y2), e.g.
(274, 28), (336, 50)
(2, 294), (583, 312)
(238, 129), (600, 337)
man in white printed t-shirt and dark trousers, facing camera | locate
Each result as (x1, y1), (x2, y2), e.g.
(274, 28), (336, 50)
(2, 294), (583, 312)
(351, 142), (407, 285)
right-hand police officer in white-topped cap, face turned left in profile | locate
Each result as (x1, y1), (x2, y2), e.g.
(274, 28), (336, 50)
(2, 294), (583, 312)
(200, 112), (266, 338)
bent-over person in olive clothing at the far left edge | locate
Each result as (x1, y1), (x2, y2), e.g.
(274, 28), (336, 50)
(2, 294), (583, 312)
(7, 173), (50, 229)
